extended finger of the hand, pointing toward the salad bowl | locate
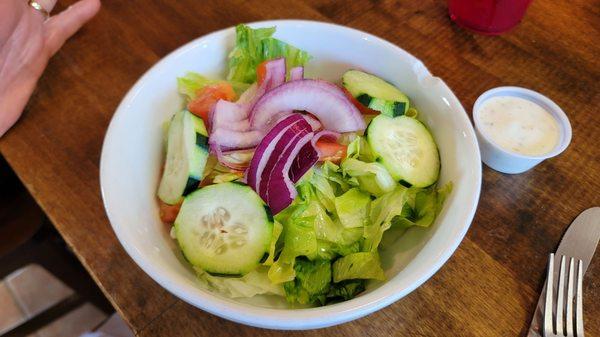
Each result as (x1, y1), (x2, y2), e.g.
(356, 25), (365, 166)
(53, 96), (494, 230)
(45, 0), (100, 56)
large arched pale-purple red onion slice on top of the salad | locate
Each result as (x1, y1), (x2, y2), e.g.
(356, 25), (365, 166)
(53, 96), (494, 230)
(250, 79), (365, 132)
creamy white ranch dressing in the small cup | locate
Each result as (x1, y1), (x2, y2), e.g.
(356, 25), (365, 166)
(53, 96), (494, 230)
(478, 96), (560, 156)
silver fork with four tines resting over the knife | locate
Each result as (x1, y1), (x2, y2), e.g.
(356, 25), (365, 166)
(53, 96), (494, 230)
(544, 254), (584, 337)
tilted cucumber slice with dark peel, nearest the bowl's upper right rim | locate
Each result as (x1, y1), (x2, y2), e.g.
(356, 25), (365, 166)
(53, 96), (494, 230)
(342, 70), (409, 117)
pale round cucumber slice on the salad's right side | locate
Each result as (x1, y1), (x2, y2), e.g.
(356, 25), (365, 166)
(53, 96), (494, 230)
(367, 115), (440, 187)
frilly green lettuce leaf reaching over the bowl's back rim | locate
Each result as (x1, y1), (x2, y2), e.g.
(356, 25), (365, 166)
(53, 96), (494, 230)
(227, 24), (310, 83)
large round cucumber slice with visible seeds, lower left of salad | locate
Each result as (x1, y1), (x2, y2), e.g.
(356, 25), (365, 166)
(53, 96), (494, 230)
(175, 182), (273, 275)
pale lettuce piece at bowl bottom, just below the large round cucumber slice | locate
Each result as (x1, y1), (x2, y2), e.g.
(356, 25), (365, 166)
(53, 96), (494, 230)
(195, 267), (284, 298)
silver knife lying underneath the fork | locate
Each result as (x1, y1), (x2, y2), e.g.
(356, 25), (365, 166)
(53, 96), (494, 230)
(527, 207), (600, 337)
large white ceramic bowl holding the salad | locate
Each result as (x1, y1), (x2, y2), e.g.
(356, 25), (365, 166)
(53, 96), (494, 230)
(100, 20), (481, 329)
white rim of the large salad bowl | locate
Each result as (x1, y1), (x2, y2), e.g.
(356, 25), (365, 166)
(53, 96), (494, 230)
(99, 20), (482, 330)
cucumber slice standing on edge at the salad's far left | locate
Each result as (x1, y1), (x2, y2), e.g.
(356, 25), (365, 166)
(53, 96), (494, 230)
(158, 110), (208, 205)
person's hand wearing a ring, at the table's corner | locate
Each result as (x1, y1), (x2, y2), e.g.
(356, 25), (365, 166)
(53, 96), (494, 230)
(0, 0), (100, 137)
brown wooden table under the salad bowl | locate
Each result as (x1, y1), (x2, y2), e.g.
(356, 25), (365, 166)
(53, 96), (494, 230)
(0, 0), (600, 336)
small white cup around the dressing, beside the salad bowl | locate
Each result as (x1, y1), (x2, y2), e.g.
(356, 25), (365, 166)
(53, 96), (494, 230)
(473, 87), (571, 174)
